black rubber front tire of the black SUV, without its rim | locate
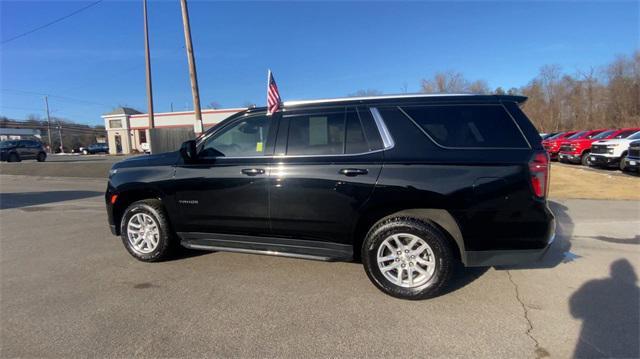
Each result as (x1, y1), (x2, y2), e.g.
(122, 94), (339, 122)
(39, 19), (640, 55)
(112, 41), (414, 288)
(120, 199), (177, 262)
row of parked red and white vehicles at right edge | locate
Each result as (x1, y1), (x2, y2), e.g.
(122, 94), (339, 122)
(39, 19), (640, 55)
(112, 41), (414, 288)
(542, 127), (640, 171)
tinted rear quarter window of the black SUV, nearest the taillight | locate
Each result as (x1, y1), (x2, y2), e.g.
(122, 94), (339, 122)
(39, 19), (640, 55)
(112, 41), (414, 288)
(402, 105), (528, 148)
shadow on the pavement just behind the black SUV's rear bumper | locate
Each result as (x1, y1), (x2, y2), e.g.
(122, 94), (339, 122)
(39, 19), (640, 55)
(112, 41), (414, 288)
(496, 201), (576, 270)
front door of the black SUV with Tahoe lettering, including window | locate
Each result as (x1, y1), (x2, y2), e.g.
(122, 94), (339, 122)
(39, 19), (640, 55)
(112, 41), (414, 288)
(174, 115), (276, 235)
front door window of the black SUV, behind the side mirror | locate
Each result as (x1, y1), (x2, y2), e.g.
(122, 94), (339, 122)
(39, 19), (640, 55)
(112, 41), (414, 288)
(198, 116), (271, 157)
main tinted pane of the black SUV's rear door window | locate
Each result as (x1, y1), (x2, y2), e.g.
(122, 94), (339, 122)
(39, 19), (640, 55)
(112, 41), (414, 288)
(287, 111), (345, 155)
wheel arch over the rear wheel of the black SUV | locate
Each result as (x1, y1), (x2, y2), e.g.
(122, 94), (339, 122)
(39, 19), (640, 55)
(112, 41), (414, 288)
(353, 208), (466, 263)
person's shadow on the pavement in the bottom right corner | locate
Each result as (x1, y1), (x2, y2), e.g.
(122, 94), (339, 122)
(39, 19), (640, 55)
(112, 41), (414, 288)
(569, 259), (640, 358)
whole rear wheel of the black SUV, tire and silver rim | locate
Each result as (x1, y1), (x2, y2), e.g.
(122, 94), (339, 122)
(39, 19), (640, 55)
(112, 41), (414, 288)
(362, 216), (457, 300)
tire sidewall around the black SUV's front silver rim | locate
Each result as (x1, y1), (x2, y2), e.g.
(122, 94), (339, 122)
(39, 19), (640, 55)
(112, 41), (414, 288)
(120, 202), (171, 262)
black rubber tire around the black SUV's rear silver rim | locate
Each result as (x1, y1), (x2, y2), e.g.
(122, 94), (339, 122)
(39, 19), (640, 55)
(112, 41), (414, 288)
(362, 216), (458, 300)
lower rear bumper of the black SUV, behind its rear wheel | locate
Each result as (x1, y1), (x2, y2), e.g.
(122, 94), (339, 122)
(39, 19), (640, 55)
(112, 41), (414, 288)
(463, 219), (556, 267)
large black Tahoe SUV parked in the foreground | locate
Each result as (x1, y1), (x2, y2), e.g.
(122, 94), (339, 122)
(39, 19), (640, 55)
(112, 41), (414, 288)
(106, 95), (555, 299)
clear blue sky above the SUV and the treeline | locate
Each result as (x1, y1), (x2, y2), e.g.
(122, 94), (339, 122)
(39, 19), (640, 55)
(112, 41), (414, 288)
(0, 0), (640, 125)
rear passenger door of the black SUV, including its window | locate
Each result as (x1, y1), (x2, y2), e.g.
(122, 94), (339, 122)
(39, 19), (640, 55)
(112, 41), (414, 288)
(269, 107), (382, 243)
